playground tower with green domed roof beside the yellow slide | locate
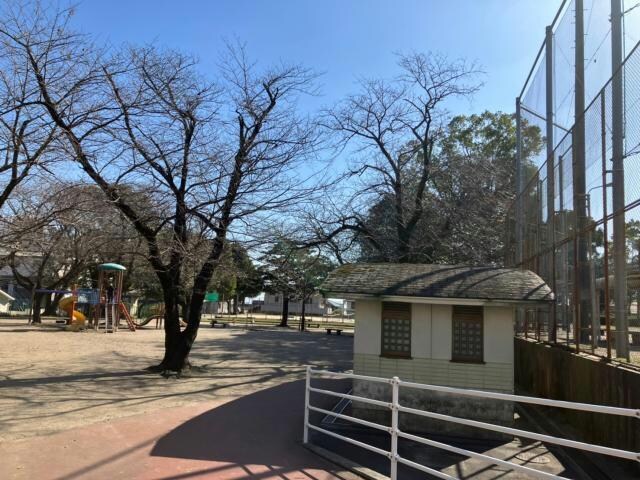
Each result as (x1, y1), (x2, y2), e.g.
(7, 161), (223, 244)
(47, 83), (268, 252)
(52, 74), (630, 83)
(93, 263), (136, 332)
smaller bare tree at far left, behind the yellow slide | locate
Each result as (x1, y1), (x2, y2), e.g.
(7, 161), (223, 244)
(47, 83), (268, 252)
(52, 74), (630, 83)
(0, 181), (115, 323)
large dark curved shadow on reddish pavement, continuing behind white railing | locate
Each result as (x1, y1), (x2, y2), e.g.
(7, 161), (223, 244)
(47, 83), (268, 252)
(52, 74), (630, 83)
(150, 378), (575, 480)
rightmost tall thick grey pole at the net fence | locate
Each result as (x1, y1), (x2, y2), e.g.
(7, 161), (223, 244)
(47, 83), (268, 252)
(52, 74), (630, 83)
(611, 0), (629, 360)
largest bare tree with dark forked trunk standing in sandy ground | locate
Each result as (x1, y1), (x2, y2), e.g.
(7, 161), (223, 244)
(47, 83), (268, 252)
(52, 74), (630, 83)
(0, 4), (324, 371)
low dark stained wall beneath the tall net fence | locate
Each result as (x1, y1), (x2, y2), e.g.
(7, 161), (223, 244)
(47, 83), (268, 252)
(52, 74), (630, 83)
(515, 338), (640, 451)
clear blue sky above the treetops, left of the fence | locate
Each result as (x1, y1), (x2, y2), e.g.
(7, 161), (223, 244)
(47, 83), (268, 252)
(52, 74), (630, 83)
(69, 0), (561, 113)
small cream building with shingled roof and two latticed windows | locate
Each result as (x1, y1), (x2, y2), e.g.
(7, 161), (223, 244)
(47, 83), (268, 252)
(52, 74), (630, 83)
(322, 264), (553, 433)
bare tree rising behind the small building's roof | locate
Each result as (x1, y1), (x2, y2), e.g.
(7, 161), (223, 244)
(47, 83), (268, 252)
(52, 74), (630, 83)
(308, 54), (480, 262)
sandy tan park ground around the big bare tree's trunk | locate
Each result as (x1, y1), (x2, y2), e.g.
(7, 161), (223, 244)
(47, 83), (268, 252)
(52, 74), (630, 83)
(0, 320), (353, 442)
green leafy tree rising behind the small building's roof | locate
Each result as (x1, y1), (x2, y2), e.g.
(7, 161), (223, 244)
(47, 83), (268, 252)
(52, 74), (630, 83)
(358, 112), (542, 264)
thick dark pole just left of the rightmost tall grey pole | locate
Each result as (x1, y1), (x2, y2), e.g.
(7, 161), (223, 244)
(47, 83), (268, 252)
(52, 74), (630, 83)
(572, 0), (595, 346)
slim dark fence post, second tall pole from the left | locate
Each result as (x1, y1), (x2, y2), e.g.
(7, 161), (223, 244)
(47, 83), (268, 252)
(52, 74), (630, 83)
(544, 25), (557, 342)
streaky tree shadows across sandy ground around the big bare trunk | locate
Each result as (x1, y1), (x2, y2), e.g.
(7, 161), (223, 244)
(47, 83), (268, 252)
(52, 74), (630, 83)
(0, 329), (353, 438)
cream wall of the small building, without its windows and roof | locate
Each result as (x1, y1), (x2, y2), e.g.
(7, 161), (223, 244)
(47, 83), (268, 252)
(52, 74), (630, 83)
(354, 300), (514, 436)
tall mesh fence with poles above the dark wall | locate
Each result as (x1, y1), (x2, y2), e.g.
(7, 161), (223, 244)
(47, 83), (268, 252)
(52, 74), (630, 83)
(506, 0), (640, 366)
